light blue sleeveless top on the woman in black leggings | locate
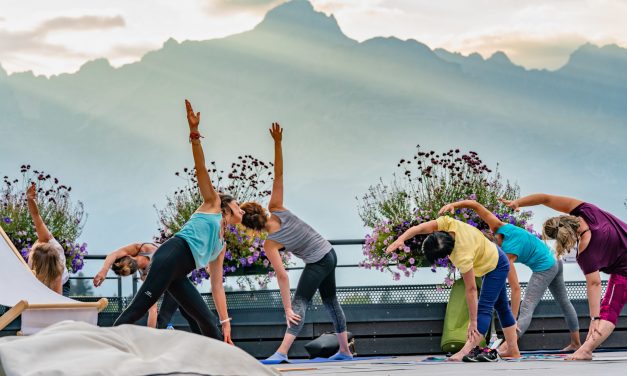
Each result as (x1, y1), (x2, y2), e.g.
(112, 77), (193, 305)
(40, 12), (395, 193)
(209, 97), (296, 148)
(176, 213), (224, 268)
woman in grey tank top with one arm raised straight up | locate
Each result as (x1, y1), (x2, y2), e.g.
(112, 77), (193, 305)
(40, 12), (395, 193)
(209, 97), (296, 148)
(241, 123), (353, 363)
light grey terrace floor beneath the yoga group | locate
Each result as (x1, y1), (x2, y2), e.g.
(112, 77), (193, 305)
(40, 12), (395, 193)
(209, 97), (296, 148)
(268, 351), (627, 376)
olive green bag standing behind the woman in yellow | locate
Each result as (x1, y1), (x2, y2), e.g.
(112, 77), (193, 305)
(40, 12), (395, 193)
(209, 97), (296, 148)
(440, 278), (485, 354)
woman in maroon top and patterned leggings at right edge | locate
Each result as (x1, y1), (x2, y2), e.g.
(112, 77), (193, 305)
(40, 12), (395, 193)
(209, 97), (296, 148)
(501, 193), (627, 360)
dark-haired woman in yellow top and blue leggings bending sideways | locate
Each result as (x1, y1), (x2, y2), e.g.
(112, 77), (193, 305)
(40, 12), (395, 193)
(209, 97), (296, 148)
(386, 217), (520, 362)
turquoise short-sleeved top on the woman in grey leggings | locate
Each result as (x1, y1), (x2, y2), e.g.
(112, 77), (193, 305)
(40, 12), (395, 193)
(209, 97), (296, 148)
(496, 223), (556, 272)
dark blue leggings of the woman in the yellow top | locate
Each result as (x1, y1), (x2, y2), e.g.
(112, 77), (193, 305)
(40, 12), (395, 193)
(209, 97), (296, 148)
(477, 247), (516, 336)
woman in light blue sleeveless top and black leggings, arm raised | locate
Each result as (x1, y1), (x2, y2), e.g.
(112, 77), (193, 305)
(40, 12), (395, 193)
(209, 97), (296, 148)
(114, 100), (242, 344)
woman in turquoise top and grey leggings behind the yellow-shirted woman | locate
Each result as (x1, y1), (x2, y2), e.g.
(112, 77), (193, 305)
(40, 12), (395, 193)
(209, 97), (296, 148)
(440, 200), (581, 356)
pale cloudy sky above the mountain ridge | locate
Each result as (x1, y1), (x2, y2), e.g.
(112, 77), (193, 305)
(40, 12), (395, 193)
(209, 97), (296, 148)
(0, 0), (627, 75)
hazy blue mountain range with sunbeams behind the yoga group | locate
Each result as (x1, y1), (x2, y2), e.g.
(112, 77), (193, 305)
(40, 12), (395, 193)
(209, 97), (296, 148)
(0, 0), (627, 250)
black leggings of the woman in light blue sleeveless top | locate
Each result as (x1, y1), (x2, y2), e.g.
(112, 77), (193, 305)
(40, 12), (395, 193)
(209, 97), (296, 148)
(113, 236), (222, 340)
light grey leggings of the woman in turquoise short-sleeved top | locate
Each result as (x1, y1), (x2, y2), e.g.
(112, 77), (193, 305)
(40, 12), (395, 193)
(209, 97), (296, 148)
(518, 260), (579, 337)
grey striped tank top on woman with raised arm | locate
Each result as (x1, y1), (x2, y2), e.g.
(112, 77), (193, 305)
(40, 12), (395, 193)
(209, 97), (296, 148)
(267, 210), (333, 264)
